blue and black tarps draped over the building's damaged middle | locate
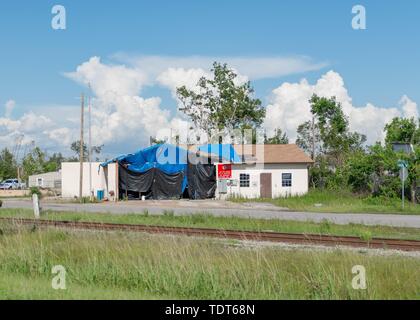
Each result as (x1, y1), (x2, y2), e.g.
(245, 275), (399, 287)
(101, 144), (239, 199)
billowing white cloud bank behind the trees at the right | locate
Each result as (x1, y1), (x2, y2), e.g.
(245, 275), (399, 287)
(265, 71), (418, 143)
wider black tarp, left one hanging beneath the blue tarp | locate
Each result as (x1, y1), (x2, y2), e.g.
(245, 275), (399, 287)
(118, 165), (184, 200)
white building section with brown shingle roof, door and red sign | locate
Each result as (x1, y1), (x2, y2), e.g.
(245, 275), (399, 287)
(216, 144), (313, 199)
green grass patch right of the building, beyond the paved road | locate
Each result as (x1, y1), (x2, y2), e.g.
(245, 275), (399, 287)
(230, 189), (420, 214)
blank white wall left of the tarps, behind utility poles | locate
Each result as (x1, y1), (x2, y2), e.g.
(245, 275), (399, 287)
(61, 162), (117, 198)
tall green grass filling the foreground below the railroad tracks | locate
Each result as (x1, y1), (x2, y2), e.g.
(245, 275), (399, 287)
(0, 222), (420, 299)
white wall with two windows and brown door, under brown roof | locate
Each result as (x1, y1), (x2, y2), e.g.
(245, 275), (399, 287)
(216, 164), (308, 198)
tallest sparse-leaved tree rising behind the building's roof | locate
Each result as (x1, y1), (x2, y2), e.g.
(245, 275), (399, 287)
(177, 62), (265, 137)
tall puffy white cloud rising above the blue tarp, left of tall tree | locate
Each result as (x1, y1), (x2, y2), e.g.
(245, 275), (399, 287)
(66, 57), (177, 147)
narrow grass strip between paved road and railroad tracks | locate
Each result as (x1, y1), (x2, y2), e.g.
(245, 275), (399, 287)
(0, 209), (420, 240)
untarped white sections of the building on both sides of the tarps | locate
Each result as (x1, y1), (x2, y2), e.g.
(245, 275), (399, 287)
(61, 144), (313, 201)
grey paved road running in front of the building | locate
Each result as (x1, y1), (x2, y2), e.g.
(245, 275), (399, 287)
(3, 199), (420, 228)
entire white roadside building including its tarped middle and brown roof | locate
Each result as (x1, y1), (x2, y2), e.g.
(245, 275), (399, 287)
(62, 144), (313, 200)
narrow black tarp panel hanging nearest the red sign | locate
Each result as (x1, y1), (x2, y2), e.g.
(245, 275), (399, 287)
(187, 164), (216, 199)
